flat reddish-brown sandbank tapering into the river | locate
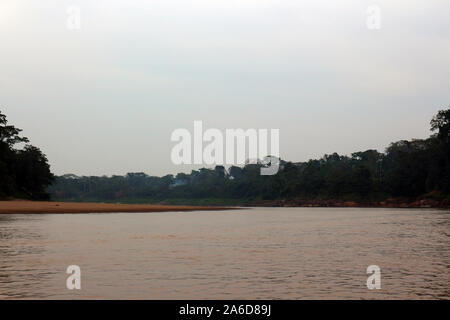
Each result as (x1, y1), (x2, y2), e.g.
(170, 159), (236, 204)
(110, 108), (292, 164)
(0, 200), (234, 214)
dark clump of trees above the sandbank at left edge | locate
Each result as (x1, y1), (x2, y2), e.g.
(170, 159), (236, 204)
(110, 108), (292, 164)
(0, 111), (54, 200)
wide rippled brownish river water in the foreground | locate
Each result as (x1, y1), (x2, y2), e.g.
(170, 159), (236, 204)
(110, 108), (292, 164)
(0, 208), (450, 299)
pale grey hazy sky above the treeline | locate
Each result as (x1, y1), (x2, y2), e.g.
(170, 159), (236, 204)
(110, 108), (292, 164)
(0, 0), (450, 175)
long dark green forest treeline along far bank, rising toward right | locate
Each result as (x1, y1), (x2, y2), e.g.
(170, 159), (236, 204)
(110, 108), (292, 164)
(49, 108), (450, 205)
